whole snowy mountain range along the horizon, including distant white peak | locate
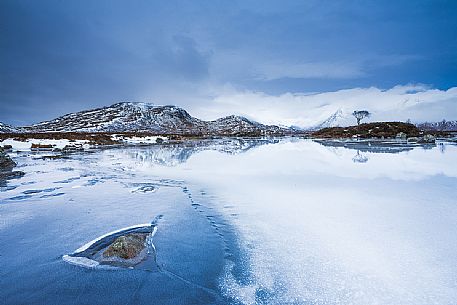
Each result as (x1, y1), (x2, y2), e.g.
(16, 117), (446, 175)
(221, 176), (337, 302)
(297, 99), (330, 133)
(0, 102), (457, 136)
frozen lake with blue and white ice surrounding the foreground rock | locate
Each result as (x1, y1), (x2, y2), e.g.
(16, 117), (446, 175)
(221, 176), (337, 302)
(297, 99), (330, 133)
(0, 139), (457, 305)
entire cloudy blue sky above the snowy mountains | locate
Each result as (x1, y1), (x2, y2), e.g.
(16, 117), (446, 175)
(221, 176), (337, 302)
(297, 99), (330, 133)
(0, 0), (457, 126)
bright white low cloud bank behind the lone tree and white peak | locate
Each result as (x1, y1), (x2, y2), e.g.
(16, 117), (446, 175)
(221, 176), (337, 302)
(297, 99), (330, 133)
(190, 85), (457, 127)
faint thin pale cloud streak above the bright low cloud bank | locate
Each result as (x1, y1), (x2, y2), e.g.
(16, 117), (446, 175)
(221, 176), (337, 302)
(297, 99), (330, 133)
(209, 48), (422, 81)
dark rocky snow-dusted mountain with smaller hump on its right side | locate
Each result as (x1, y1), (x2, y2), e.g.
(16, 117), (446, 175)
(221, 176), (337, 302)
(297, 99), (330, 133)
(24, 102), (289, 135)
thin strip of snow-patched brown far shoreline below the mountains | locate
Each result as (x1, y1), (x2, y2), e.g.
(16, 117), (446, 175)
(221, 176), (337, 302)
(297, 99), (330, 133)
(0, 132), (457, 154)
